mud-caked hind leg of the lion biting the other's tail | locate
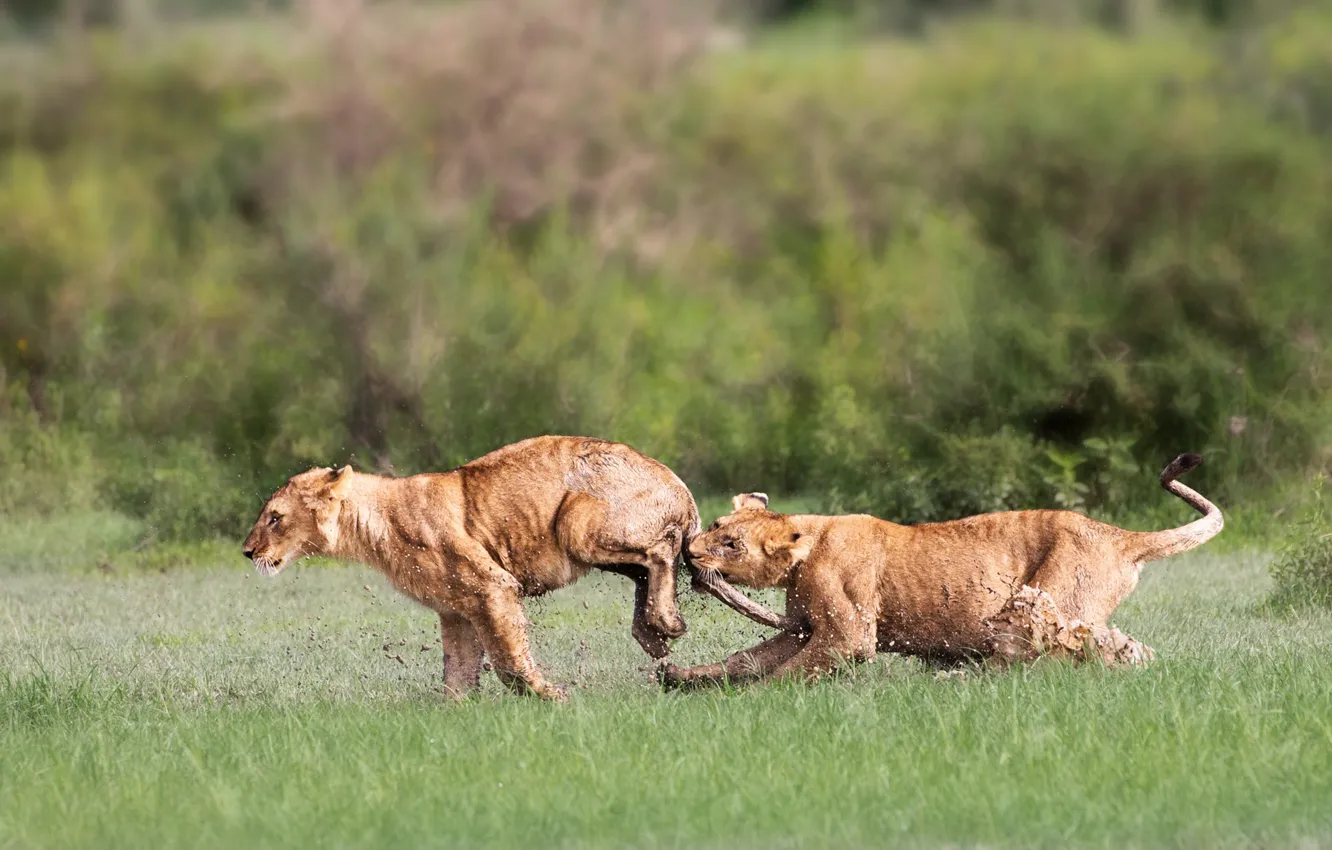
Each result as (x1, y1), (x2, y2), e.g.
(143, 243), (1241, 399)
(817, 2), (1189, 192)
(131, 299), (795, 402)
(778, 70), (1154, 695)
(986, 585), (1156, 666)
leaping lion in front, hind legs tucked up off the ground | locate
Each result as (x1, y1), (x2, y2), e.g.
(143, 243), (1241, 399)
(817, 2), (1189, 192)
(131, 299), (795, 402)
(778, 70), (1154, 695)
(244, 437), (699, 698)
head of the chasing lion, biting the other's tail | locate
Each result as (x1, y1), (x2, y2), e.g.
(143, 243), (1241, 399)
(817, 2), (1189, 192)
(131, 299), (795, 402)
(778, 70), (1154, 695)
(689, 493), (814, 588)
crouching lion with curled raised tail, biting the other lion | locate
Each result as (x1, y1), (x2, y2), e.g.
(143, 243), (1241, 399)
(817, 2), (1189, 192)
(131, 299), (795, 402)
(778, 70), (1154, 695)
(659, 454), (1223, 686)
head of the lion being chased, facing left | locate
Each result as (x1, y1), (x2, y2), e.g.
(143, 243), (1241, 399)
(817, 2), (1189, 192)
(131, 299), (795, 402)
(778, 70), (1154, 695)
(241, 466), (354, 577)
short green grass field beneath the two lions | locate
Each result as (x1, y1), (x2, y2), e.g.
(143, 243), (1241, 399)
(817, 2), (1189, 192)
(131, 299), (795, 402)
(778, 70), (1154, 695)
(0, 505), (1332, 847)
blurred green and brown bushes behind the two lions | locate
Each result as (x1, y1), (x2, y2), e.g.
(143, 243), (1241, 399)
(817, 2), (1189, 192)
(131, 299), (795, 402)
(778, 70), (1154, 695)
(0, 0), (1332, 537)
